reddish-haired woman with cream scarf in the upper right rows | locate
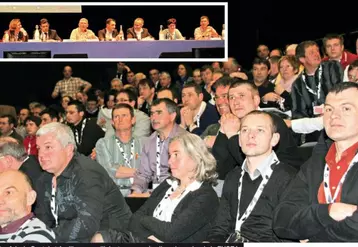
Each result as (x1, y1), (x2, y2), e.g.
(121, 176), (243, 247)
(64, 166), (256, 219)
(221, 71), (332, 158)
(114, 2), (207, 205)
(275, 56), (300, 111)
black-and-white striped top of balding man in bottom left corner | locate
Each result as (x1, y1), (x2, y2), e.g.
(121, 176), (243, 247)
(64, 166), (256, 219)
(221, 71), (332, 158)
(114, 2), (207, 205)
(0, 217), (56, 243)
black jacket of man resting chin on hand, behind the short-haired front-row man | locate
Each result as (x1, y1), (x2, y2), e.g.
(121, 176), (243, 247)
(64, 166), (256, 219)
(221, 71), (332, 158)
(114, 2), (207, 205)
(212, 113), (303, 179)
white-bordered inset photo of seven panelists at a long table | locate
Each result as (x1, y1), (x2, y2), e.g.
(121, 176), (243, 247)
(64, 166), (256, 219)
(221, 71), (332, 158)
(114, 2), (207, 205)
(0, 2), (228, 61)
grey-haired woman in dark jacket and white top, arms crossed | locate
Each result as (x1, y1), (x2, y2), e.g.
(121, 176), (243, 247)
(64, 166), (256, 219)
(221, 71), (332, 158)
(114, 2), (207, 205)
(92, 133), (219, 243)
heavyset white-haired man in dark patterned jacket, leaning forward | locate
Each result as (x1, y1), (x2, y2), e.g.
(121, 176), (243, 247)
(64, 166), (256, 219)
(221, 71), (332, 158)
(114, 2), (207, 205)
(35, 123), (132, 243)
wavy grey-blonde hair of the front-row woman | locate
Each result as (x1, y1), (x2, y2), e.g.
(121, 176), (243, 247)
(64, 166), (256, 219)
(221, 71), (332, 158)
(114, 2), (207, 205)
(169, 133), (218, 185)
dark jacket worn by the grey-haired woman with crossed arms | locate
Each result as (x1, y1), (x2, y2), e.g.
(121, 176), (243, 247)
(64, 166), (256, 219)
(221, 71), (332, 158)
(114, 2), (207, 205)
(129, 181), (219, 243)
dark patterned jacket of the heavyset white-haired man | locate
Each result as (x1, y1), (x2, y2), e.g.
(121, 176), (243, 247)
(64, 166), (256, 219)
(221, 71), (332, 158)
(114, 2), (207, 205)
(35, 153), (132, 243)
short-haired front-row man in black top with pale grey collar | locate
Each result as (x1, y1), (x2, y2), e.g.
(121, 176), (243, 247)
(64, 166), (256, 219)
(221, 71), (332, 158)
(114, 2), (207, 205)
(208, 110), (296, 243)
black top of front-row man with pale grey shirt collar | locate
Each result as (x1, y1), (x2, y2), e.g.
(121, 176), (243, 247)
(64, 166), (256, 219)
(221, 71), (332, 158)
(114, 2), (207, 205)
(207, 163), (296, 243)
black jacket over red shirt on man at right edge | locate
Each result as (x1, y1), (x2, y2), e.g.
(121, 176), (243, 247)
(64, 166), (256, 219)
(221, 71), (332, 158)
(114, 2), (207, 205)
(273, 131), (358, 242)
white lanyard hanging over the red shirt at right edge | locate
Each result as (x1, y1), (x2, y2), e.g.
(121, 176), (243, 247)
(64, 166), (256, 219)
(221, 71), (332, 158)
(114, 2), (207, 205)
(323, 154), (358, 203)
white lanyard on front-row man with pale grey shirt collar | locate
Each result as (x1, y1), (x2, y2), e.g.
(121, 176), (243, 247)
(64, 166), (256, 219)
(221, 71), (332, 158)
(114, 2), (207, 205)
(235, 153), (280, 232)
